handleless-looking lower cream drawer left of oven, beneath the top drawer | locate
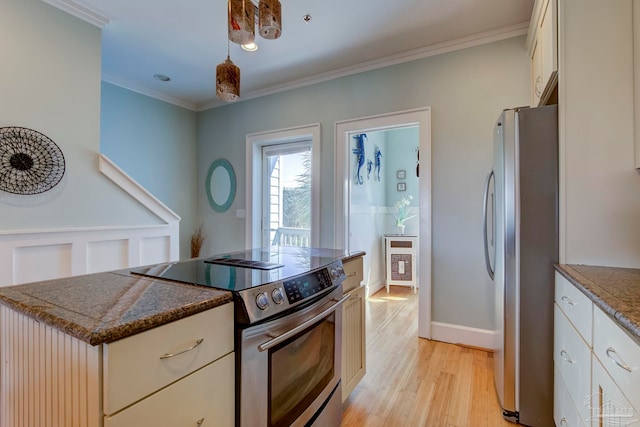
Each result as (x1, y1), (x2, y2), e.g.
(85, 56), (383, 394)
(104, 353), (235, 427)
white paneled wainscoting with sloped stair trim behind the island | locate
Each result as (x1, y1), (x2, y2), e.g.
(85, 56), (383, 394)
(0, 155), (180, 286)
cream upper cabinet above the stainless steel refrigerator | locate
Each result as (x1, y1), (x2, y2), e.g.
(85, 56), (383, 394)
(527, 0), (558, 107)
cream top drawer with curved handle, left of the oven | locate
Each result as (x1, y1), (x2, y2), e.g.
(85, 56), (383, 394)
(103, 303), (233, 415)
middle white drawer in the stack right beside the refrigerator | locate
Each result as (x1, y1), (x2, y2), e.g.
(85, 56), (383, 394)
(553, 304), (591, 421)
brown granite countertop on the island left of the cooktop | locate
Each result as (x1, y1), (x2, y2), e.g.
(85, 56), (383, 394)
(0, 273), (232, 345)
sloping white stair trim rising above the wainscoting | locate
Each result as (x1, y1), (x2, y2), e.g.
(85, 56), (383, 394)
(98, 154), (180, 224)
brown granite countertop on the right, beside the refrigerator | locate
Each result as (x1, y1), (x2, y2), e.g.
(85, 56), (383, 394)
(556, 264), (640, 344)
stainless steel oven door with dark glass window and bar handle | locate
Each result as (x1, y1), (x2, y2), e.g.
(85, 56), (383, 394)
(236, 286), (348, 427)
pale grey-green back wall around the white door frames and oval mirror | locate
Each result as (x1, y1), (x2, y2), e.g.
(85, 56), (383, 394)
(198, 37), (530, 329)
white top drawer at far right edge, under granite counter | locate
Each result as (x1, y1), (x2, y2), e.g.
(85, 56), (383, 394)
(593, 307), (640, 408)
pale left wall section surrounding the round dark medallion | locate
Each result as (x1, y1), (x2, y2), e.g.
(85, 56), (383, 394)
(0, 0), (160, 231)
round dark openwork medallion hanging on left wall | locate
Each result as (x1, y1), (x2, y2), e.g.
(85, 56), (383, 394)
(0, 127), (65, 194)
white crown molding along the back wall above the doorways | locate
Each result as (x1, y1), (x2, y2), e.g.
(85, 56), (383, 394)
(196, 22), (529, 111)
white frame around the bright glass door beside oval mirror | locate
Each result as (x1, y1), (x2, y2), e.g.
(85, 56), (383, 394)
(245, 123), (321, 249)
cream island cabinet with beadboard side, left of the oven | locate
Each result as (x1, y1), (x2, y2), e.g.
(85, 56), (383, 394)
(0, 303), (235, 427)
